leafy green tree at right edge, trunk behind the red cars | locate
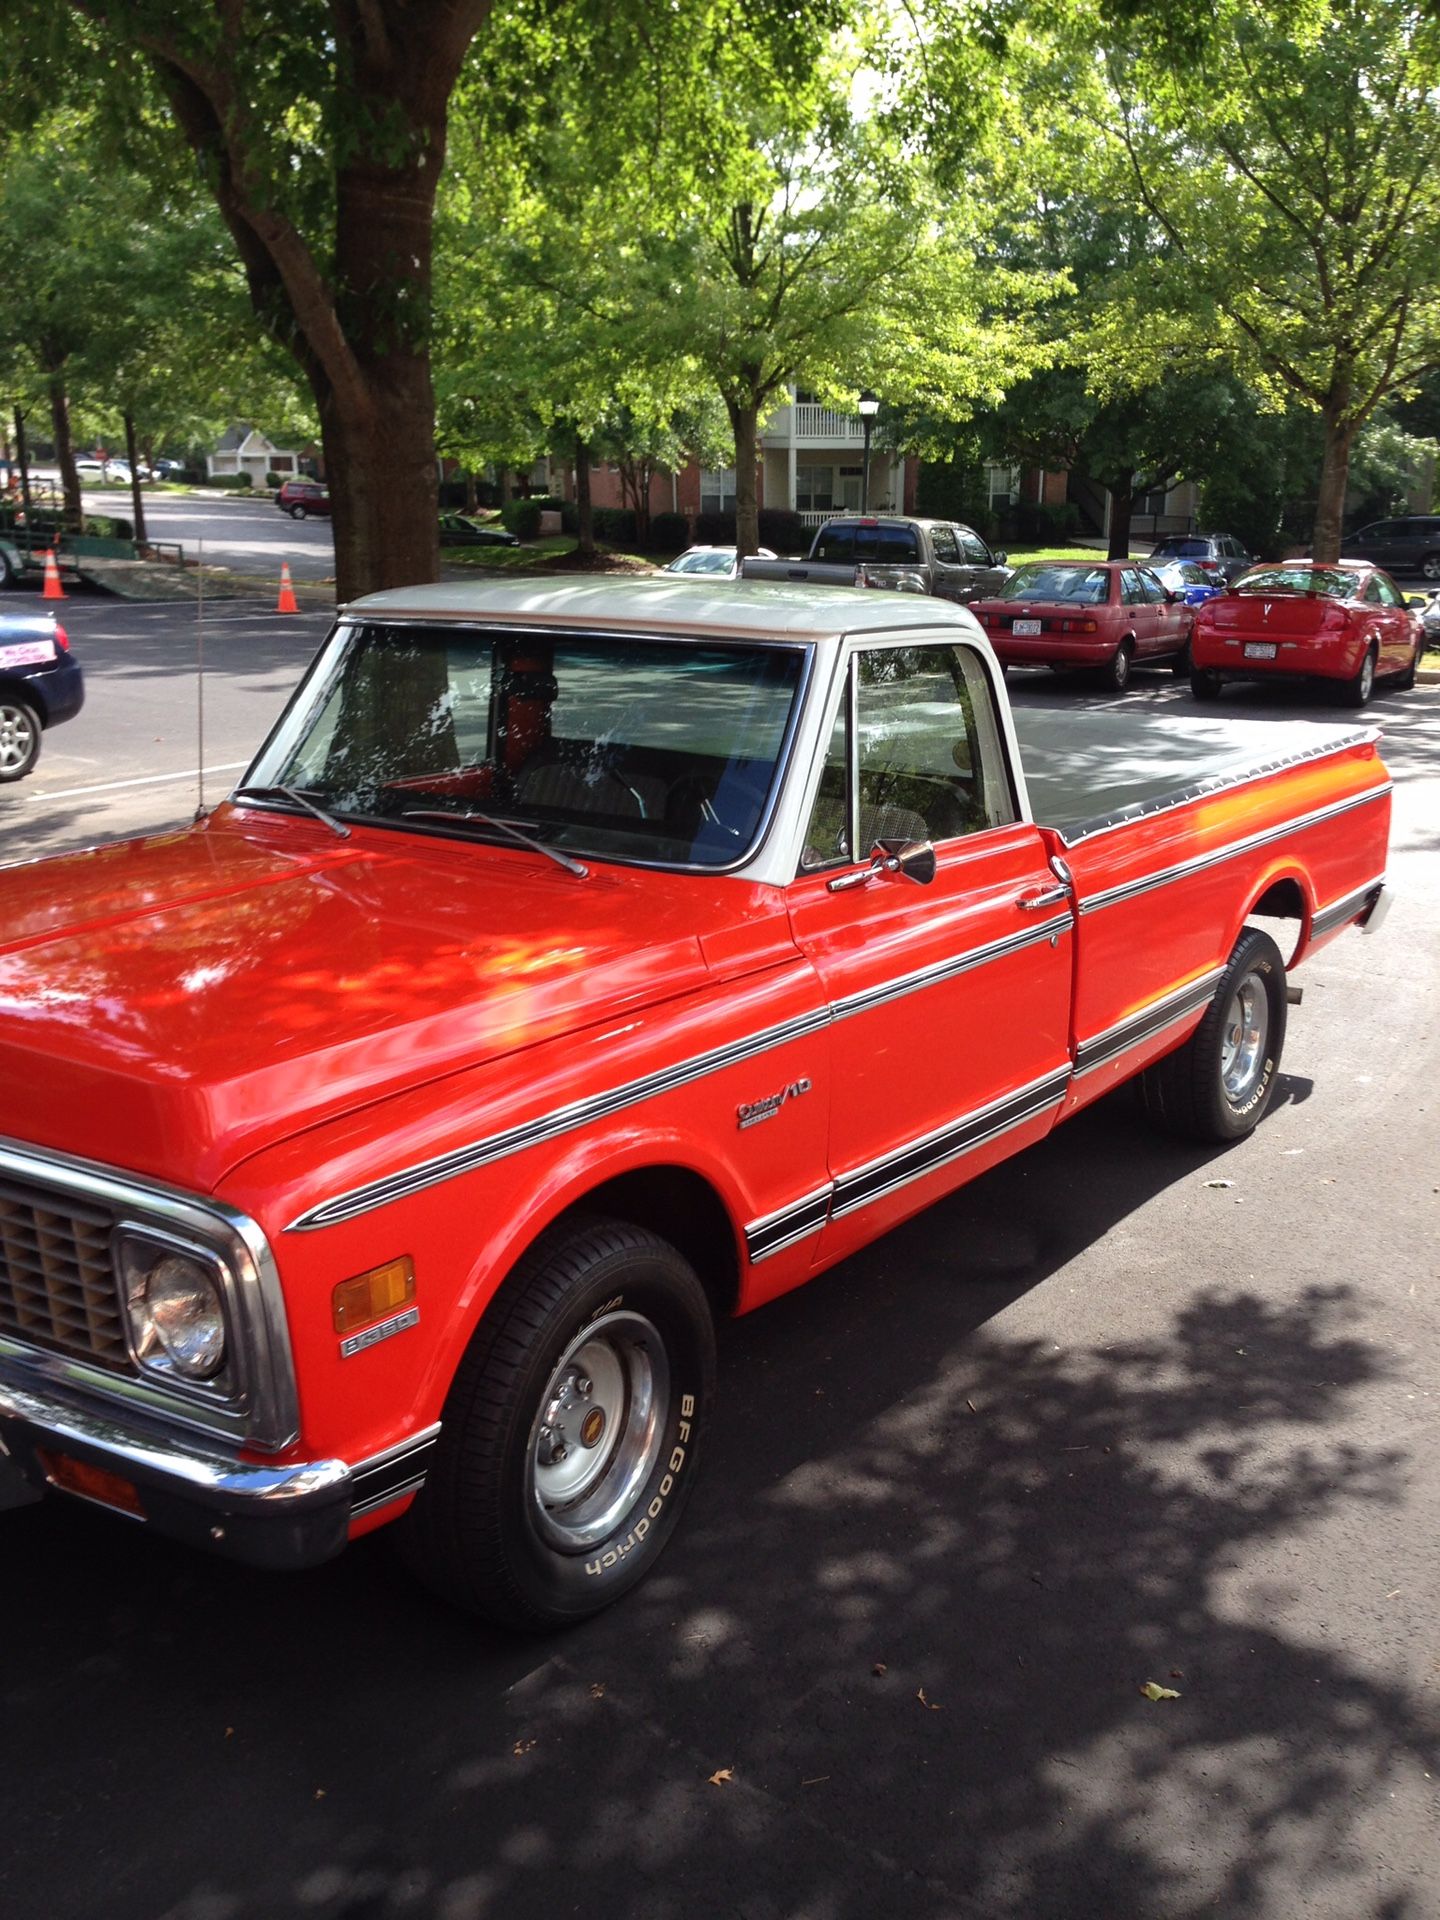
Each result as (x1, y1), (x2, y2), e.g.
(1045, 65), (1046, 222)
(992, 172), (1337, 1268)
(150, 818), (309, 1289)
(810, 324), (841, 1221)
(1113, 0), (1440, 561)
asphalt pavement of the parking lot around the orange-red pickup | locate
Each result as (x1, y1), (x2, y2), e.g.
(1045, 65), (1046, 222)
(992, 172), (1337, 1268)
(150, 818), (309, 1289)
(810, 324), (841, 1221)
(0, 603), (1440, 1920)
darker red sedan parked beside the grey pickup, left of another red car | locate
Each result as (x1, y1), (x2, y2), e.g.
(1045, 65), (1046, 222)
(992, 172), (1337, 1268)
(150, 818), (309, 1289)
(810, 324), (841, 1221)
(970, 561), (1194, 693)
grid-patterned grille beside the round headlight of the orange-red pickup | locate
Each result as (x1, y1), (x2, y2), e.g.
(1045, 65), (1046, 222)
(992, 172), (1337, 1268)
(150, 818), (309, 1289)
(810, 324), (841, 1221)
(0, 1179), (131, 1367)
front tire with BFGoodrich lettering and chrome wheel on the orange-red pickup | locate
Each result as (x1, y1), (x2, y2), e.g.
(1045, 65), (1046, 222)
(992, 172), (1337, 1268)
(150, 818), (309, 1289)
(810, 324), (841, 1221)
(401, 1217), (714, 1630)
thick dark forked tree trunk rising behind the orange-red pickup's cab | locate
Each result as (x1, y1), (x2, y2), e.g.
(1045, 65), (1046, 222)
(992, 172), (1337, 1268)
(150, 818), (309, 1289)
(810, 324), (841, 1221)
(142, 0), (490, 601)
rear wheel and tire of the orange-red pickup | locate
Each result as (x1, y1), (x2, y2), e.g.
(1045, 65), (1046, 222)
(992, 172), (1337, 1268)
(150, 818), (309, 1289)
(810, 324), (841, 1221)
(1140, 927), (1286, 1140)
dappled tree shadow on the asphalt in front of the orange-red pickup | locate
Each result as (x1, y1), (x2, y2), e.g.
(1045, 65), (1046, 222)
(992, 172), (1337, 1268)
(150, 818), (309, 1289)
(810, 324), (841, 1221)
(0, 1083), (1438, 1920)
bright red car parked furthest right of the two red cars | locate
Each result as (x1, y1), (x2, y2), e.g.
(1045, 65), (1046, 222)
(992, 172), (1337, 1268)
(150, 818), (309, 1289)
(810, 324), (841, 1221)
(1190, 561), (1425, 707)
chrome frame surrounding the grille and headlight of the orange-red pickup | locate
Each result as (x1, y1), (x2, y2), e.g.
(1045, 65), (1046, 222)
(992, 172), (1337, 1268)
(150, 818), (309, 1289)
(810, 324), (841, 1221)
(0, 1139), (300, 1452)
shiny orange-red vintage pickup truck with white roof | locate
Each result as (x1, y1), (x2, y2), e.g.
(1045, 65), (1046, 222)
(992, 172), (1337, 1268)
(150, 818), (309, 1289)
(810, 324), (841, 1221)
(0, 576), (1390, 1626)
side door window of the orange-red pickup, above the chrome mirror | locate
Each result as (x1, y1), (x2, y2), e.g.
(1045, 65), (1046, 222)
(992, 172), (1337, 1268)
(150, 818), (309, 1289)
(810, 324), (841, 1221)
(801, 645), (1018, 870)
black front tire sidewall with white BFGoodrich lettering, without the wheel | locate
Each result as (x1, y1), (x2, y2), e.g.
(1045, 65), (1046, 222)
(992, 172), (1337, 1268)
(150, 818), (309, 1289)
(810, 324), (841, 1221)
(497, 1246), (714, 1624)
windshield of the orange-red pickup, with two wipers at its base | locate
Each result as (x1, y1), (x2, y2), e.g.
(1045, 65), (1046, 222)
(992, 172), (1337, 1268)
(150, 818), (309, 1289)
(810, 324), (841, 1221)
(238, 624), (806, 868)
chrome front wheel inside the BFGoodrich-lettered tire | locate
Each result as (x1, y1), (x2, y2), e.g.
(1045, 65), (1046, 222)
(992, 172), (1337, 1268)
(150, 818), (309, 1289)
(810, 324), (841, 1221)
(528, 1309), (670, 1553)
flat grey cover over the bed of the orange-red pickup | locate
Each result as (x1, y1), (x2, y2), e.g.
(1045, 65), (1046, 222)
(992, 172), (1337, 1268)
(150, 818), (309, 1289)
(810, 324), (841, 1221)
(1012, 707), (1379, 845)
